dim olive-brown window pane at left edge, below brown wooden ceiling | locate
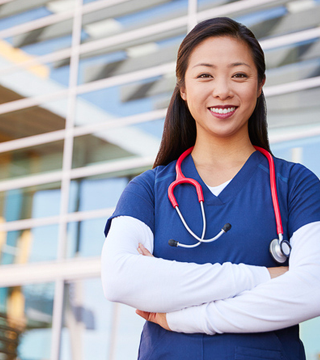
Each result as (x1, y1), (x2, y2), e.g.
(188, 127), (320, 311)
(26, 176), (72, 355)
(0, 140), (64, 180)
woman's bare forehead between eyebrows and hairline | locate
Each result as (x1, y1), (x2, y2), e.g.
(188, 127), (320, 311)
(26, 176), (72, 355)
(188, 36), (255, 67)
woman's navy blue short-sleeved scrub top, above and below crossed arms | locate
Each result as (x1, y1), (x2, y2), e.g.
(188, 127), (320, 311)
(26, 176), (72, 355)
(105, 151), (320, 360)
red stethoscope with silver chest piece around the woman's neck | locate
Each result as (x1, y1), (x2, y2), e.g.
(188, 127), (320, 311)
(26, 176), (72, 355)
(168, 146), (291, 263)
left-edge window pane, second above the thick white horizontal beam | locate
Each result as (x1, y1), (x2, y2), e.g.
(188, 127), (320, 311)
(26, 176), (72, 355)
(0, 182), (61, 221)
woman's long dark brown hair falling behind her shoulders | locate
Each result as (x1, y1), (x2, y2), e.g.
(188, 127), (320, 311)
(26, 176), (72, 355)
(153, 17), (270, 167)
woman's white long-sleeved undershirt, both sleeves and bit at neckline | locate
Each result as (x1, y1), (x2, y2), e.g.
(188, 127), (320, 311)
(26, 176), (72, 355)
(101, 182), (320, 335)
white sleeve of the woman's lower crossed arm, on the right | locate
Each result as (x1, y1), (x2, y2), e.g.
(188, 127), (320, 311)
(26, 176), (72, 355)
(167, 223), (320, 335)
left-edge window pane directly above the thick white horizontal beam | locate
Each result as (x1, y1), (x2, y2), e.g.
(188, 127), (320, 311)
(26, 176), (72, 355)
(0, 225), (59, 265)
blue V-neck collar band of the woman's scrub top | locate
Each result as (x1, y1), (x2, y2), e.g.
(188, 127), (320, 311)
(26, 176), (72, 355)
(182, 151), (264, 205)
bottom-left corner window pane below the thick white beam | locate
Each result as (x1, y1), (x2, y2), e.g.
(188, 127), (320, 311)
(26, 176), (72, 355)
(0, 283), (54, 360)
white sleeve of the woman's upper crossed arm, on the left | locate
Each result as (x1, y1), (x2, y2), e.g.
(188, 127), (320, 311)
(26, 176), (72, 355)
(102, 218), (270, 312)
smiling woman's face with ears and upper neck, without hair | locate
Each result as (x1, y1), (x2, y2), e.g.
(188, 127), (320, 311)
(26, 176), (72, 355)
(180, 36), (264, 144)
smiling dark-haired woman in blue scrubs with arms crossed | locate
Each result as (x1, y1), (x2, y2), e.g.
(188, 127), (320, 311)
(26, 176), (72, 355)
(102, 18), (320, 360)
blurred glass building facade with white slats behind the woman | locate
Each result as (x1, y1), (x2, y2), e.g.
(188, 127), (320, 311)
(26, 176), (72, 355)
(0, 0), (320, 360)
